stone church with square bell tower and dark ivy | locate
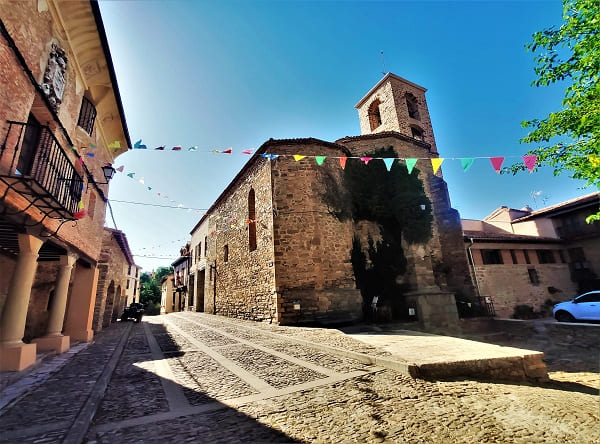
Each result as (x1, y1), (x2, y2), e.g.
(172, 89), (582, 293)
(188, 73), (472, 328)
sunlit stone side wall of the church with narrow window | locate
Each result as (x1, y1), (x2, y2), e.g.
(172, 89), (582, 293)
(203, 159), (277, 322)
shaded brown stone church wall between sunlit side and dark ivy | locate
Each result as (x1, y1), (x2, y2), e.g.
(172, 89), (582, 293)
(269, 140), (362, 324)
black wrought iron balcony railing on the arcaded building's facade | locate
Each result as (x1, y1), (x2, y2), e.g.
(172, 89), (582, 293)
(0, 117), (83, 219)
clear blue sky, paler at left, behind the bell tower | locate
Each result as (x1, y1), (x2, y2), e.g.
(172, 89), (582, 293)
(100, 0), (591, 270)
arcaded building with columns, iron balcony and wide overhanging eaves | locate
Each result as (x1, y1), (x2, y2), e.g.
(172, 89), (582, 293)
(0, 0), (131, 370)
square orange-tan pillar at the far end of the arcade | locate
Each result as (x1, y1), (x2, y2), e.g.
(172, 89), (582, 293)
(64, 264), (98, 342)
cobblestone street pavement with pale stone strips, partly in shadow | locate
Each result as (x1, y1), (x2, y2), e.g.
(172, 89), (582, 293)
(0, 313), (600, 443)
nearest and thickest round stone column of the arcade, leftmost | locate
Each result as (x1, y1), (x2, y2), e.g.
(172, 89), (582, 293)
(0, 234), (44, 371)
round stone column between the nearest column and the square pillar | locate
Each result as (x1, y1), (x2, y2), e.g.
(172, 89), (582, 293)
(33, 254), (77, 353)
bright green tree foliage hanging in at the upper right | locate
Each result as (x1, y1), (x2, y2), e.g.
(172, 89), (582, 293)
(510, 0), (600, 222)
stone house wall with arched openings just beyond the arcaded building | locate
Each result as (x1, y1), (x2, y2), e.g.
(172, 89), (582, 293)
(92, 230), (129, 332)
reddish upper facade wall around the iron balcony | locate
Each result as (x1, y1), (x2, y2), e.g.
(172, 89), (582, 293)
(0, 0), (117, 260)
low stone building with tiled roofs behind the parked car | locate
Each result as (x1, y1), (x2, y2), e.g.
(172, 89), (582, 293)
(462, 193), (600, 317)
